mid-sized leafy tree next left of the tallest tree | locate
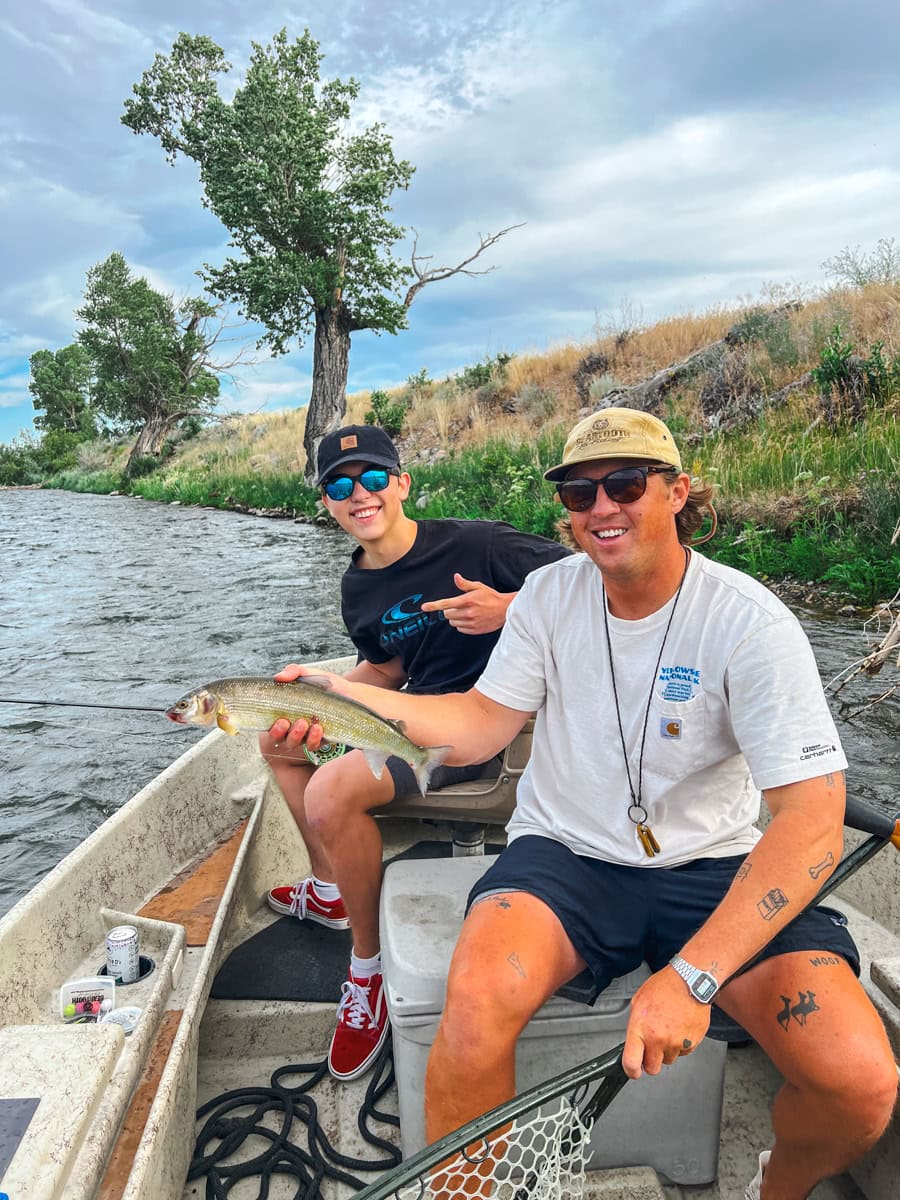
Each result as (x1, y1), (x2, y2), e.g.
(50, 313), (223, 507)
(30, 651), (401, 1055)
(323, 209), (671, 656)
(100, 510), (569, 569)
(76, 253), (236, 474)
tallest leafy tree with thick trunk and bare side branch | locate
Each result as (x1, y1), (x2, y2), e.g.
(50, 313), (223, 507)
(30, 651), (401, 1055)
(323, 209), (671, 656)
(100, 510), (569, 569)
(122, 29), (518, 480)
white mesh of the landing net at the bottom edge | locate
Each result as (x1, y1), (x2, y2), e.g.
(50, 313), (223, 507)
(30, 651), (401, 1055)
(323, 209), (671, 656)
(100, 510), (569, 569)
(394, 1097), (590, 1200)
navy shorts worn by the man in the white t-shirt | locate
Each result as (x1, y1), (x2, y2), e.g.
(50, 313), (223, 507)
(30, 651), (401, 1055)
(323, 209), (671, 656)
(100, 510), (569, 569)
(468, 834), (859, 1003)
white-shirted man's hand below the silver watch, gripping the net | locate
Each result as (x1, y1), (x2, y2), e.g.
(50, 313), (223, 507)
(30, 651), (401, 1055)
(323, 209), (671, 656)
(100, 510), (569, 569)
(622, 966), (709, 1079)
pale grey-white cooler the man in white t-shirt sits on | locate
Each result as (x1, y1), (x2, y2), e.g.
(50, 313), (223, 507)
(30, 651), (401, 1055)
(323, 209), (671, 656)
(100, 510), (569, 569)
(380, 856), (727, 1183)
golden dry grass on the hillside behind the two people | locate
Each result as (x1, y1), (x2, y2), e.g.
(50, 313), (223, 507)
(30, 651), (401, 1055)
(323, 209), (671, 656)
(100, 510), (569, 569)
(151, 284), (900, 482)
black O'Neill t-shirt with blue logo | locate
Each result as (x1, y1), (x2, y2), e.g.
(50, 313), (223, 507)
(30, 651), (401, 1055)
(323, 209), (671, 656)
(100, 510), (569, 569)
(341, 520), (570, 692)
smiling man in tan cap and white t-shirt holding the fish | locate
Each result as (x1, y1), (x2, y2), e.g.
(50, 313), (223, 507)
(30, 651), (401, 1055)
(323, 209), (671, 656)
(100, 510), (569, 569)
(278, 409), (896, 1200)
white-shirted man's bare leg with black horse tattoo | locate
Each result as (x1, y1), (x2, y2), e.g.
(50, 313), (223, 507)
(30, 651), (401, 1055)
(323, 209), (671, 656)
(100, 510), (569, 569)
(720, 950), (898, 1200)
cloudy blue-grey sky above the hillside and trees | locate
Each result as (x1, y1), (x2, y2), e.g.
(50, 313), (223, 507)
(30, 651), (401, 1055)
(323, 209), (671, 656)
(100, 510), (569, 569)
(0, 0), (900, 442)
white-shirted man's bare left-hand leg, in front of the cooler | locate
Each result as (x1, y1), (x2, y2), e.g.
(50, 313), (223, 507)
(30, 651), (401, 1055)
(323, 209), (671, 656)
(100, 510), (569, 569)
(425, 892), (584, 1142)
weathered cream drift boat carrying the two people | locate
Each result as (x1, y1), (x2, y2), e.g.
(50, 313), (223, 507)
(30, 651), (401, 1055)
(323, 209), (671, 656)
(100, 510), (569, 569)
(0, 660), (900, 1200)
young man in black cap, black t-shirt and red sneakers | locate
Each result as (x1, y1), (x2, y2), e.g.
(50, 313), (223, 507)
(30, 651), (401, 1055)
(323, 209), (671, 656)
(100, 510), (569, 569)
(260, 425), (569, 1079)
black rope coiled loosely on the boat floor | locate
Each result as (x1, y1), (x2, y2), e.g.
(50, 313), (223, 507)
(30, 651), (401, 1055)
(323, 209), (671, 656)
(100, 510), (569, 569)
(187, 1033), (401, 1200)
